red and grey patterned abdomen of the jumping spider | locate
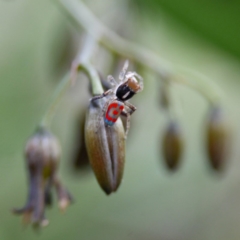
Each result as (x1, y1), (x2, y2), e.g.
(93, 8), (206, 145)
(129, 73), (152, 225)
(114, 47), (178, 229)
(104, 101), (124, 126)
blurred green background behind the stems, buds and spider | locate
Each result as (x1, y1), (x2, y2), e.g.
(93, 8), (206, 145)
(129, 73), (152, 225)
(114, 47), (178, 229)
(0, 0), (240, 240)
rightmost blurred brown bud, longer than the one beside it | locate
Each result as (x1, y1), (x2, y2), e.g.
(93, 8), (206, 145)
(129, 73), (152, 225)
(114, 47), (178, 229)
(207, 106), (229, 171)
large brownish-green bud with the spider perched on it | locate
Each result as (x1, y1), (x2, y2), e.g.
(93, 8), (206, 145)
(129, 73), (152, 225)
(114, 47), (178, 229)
(85, 98), (125, 194)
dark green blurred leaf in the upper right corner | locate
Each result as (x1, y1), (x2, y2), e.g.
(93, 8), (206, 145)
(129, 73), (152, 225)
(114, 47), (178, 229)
(132, 0), (240, 58)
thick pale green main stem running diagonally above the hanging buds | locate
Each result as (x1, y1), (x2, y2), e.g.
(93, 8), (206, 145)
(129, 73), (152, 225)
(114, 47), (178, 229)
(56, 0), (221, 104)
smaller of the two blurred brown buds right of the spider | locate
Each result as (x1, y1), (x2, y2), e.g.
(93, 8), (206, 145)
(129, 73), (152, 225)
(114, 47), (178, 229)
(162, 121), (183, 170)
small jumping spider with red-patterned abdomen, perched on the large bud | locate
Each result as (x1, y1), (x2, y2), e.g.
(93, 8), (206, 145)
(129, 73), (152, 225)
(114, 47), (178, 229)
(91, 61), (143, 138)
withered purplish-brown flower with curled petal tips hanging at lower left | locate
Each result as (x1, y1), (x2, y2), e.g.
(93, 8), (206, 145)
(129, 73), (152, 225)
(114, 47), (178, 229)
(13, 128), (71, 227)
